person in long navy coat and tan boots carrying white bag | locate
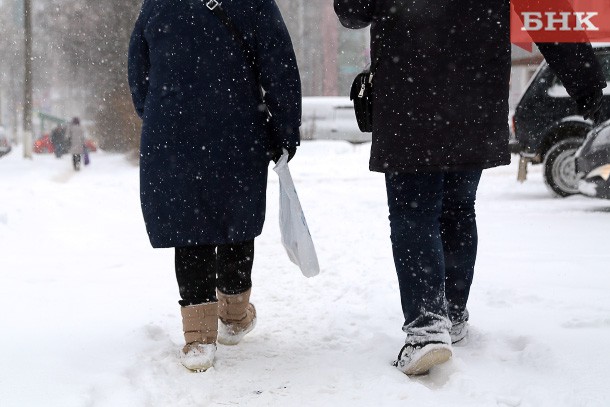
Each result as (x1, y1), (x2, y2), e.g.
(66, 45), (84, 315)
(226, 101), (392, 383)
(129, 0), (301, 370)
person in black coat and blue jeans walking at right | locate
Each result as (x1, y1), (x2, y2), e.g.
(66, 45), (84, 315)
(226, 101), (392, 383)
(334, 0), (606, 374)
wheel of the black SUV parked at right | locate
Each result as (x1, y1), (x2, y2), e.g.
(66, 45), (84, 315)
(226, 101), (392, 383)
(544, 138), (584, 198)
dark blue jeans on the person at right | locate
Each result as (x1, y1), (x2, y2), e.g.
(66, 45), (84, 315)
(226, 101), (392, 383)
(386, 170), (481, 334)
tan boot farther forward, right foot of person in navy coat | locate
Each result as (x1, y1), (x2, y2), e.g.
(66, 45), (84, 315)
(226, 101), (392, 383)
(216, 289), (256, 345)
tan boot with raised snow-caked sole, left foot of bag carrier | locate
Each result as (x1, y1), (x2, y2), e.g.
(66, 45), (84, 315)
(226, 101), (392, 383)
(180, 302), (218, 372)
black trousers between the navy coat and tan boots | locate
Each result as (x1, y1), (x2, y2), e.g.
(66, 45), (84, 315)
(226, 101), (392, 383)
(176, 240), (254, 307)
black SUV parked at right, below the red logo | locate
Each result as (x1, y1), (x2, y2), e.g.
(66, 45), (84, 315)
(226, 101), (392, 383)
(510, 44), (610, 197)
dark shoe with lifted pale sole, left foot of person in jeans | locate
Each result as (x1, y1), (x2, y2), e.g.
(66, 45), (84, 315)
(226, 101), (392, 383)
(393, 342), (452, 376)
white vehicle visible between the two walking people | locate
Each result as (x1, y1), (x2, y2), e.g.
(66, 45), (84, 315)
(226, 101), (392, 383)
(301, 96), (371, 143)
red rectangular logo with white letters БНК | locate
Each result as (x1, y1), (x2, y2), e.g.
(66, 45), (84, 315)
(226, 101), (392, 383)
(511, 0), (610, 50)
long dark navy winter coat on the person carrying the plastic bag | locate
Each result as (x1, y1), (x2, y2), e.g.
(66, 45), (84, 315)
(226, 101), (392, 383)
(129, 0), (301, 247)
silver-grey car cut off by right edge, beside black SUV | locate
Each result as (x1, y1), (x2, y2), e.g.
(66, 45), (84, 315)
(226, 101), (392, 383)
(576, 120), (610, 199)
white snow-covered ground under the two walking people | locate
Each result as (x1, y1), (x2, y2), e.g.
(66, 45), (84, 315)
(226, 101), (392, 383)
(0, 142), (610, 407)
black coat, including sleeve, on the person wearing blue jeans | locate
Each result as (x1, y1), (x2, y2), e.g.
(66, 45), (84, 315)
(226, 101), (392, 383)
(334, 0), (606, 172)
